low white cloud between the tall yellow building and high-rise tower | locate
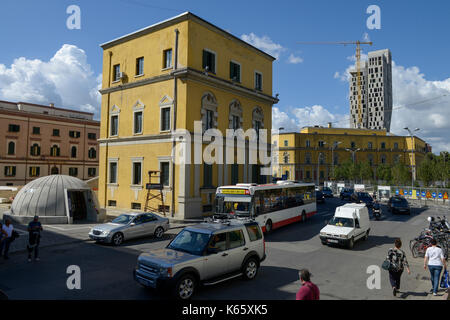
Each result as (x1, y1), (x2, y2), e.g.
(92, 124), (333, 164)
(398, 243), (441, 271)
(272, 105), (349, 132)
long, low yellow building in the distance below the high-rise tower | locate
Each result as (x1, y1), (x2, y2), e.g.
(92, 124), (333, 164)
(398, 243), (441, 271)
(272, 124), (430, 183)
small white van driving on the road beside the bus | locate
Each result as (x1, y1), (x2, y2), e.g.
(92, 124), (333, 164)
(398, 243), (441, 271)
(320, 203), (370, 249)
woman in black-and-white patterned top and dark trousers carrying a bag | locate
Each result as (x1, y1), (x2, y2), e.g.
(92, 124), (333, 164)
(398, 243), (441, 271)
(387, 239), (411, 297)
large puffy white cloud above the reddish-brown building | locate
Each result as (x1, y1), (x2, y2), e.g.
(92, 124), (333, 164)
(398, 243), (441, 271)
(0, 44), (101, 116)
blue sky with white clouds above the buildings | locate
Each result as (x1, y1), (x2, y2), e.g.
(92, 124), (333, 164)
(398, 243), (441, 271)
(0, 0), (450, 153)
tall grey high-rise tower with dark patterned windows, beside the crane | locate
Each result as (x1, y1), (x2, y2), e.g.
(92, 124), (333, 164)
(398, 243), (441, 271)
(350, 49), (393, 132)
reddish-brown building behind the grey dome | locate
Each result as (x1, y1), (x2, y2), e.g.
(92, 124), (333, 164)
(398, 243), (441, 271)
(0, 101), (100, 186)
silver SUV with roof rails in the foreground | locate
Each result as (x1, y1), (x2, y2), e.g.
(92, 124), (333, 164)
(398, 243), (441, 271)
(133, 219), (266, 299)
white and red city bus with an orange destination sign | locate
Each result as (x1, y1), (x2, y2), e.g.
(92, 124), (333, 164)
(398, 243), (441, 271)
(215, 181), (317, 233)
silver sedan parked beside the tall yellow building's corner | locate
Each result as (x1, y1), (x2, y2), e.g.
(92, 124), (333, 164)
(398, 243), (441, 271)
(89, 212), (169, 246)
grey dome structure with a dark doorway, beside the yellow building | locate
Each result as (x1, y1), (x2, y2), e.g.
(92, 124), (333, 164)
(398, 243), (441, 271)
(10, 175), (104, 224)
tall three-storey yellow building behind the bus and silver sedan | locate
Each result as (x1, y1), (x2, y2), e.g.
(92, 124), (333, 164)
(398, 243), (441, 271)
(99, 12), (278, 218)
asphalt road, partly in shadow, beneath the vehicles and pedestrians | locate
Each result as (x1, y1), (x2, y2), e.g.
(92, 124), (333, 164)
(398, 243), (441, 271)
(0, 199), (449, 300)
